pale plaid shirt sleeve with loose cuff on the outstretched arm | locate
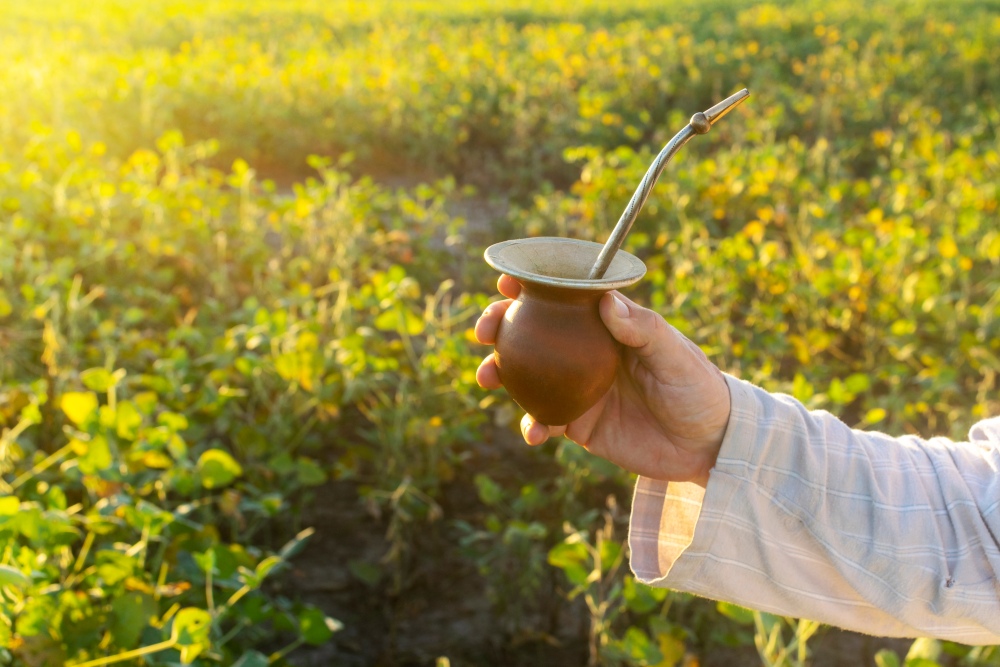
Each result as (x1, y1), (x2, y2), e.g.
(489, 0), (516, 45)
(629, 376), (1000, 644)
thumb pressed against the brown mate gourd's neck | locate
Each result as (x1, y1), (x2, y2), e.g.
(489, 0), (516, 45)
(600, 292), (687, 372)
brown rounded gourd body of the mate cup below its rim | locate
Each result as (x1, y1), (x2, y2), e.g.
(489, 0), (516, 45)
(494, 279), (619, 426)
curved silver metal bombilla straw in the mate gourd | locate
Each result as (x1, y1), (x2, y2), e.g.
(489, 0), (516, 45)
(587, 88), (750, 280)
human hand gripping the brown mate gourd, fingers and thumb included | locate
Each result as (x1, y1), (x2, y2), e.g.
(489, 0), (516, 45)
(475, 275), (730, 486)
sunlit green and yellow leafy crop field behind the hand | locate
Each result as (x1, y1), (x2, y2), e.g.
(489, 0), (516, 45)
(0, 0), (1000, 667)
